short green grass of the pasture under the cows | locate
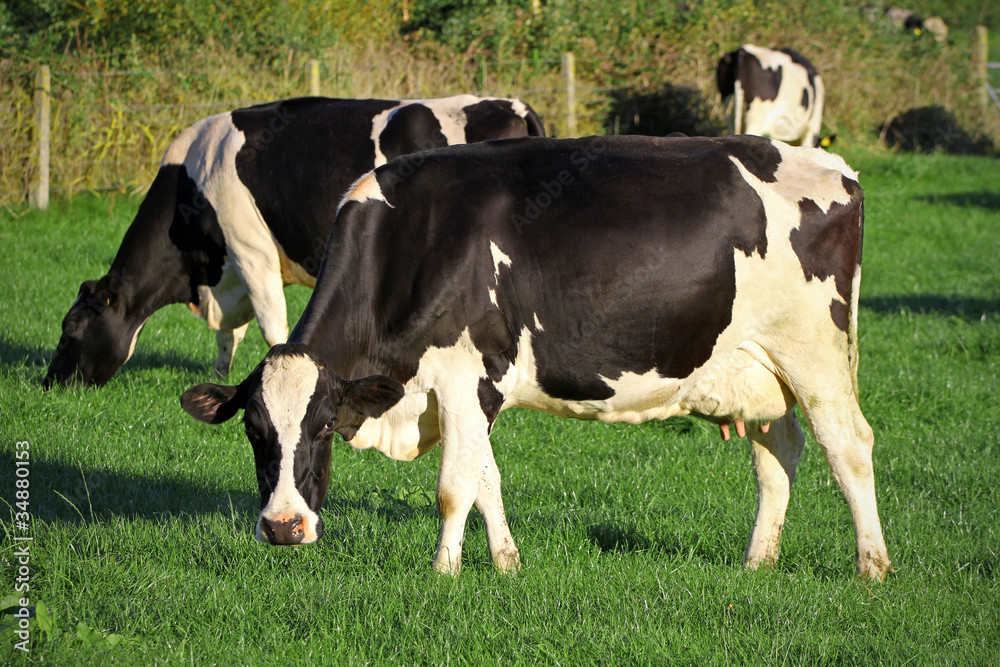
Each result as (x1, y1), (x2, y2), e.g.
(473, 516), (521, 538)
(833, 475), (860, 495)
(0, 149), (1000, 665)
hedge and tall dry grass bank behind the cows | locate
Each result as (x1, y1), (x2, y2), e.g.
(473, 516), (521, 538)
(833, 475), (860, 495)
(0, 0), (1000, 204)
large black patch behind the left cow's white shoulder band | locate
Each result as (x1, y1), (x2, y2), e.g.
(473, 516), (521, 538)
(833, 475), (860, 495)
(232, 97), (399, 276)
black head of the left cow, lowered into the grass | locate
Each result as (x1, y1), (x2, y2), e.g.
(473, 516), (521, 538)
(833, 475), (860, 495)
(42, 273), (145, 389)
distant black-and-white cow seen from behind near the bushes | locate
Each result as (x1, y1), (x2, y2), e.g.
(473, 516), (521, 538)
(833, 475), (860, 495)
(715, 44), (831, 146)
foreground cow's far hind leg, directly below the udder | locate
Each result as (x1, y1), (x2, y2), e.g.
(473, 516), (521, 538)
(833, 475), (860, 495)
(743, 409), (805, 568)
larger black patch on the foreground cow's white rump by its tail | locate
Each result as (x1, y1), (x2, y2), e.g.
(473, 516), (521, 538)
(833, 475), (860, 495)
(789, 178), (862, 306)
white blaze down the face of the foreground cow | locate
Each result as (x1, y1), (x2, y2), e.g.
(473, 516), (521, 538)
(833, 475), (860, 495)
(258, 355), (319, 543)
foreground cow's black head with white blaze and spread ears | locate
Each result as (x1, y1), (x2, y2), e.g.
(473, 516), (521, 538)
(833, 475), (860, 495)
(181, 343), (403, 544)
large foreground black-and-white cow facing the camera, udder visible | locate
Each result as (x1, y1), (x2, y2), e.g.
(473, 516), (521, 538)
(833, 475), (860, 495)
(181, 136), (891, 579)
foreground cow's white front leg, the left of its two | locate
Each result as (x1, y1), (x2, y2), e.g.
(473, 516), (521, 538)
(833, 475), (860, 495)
(434, 412), (492, 575)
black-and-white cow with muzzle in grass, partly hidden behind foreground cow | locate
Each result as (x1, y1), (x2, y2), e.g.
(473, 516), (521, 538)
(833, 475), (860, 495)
(43, 95), (544, 388)
